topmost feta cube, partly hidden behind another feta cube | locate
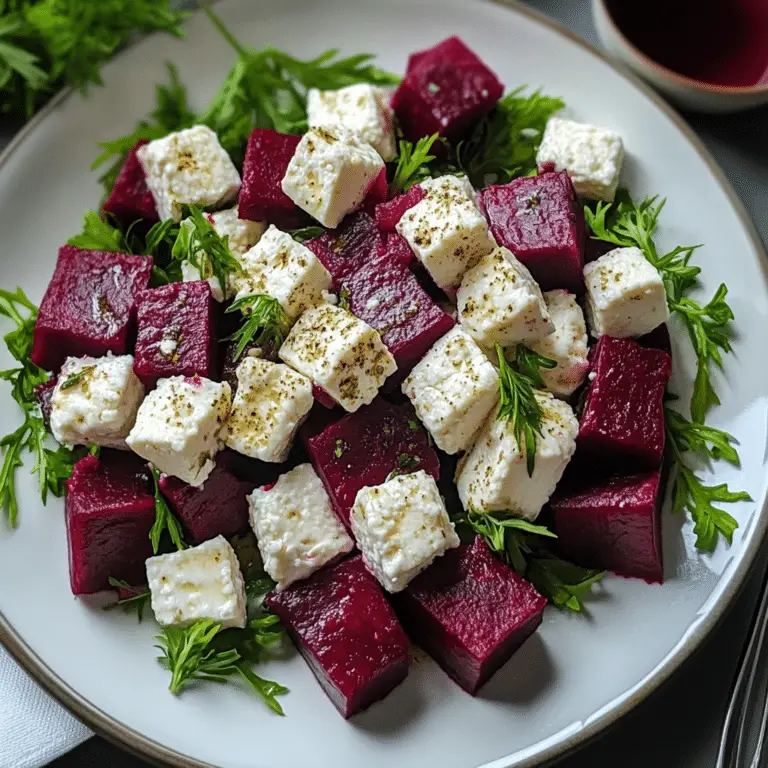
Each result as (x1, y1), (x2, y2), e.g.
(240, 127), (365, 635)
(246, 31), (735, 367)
(307, 83), (397, 162)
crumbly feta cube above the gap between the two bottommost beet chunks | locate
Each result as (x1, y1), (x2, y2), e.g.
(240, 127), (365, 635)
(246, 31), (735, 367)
(350, 470), (460, 592)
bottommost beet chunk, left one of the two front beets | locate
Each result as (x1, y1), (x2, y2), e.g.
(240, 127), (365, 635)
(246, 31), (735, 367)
(267, 555), (408, 717)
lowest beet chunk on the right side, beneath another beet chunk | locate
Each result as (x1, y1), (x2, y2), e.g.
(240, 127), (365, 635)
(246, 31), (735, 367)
(551, 470), (664, 582)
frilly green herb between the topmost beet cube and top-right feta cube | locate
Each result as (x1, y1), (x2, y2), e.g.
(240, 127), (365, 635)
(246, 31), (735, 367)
(456, 87), (565, 187)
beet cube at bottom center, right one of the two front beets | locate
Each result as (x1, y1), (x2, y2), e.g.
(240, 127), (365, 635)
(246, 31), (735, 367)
(395, 536), (547, 695)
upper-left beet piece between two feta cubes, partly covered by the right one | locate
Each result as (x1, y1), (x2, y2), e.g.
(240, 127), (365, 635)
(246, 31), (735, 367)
(237, 128), (309, 229)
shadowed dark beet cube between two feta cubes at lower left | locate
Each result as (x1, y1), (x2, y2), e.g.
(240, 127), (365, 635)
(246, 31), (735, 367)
(160, 451), (255, 544)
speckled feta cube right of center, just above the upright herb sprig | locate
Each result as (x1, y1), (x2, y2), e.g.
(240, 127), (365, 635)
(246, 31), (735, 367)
(456, 247), (554, 347)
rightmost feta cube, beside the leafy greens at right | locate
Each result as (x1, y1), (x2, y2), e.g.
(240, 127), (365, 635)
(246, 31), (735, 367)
(584, 248), (669, 339)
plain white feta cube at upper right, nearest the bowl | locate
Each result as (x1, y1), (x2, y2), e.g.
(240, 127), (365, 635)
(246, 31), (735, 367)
(536, 117), (624, 202)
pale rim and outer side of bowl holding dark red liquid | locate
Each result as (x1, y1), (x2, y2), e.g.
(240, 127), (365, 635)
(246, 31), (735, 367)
(592, 0), (768, 112)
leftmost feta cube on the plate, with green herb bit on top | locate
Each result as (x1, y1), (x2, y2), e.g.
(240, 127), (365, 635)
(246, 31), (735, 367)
(50, 355), (144, 449)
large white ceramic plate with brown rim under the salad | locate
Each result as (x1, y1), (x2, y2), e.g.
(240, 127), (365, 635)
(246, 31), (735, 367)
(0, 0), (768, 768)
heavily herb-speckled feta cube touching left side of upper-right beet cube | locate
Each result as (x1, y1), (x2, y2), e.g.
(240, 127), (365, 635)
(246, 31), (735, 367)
(395, 176), (496, 290)
